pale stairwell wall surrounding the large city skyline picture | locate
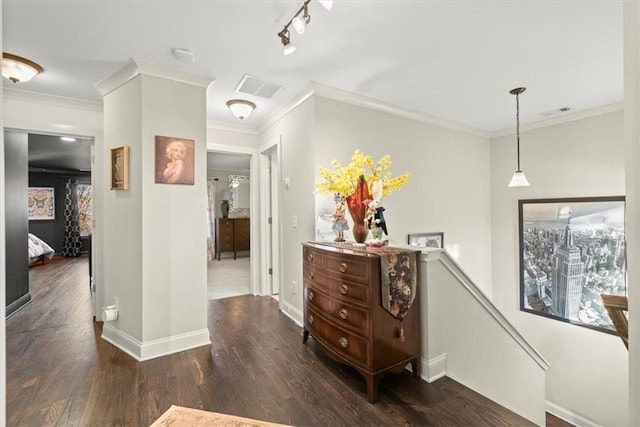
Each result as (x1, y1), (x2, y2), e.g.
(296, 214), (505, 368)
(491, 112), (628, 425)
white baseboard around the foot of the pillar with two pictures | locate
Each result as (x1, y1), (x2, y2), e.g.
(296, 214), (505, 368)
(102, 322), (211, 362)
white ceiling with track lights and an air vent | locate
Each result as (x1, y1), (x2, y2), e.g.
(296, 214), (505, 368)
(3, 0), (623, 131)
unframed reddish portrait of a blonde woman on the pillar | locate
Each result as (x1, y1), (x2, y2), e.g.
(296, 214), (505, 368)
(155, 135), (195, 185)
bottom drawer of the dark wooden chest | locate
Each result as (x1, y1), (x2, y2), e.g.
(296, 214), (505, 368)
(305, 306), (371, 369)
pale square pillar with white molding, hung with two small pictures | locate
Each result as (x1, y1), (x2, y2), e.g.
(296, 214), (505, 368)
(98, 60), (210, 360)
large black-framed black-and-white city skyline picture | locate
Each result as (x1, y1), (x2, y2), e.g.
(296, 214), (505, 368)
(518, 196), (627, 334)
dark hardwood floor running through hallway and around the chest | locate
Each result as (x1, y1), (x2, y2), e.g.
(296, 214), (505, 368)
(6, 258), (569, 427)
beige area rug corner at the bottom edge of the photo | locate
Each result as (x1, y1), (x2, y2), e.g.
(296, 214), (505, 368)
(151, 405), (290, 427)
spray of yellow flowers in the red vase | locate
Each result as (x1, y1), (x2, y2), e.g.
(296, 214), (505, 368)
(316, 150), (409, 198)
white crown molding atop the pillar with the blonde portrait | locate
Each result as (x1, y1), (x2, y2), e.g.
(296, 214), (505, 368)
(95, 58), (215, 97)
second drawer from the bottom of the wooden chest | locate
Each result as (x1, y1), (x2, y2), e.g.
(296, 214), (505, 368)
(306, 287), (369, 335)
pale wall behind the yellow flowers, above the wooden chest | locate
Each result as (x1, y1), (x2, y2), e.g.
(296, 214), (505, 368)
(308, 96), (491, 295)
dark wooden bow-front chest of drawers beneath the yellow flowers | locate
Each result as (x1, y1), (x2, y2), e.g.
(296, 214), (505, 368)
(303, 243), (421, 403)
